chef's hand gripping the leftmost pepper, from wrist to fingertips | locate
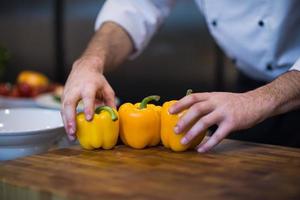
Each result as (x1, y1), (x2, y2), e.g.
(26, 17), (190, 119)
(61, 56), (116, 140)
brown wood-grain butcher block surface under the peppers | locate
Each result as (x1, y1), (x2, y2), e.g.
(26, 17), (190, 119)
(0, 140), (300, 200)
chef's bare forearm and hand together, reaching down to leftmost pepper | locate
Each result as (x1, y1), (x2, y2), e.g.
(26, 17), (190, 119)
(61, 22), (133, 140)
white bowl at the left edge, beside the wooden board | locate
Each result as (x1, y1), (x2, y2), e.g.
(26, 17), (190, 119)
(0, 108), (65, 160)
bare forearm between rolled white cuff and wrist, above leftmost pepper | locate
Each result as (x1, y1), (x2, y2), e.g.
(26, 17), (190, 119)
(82, 22), (133, 72)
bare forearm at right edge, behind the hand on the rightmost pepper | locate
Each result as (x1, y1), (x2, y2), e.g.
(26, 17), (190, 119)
(249, 71), (300, 118)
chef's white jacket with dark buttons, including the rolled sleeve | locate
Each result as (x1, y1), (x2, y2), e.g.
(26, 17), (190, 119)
(95, 0), (300, 81)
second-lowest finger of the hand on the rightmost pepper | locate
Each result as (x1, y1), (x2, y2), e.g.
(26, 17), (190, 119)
(181, 113), (219, 144)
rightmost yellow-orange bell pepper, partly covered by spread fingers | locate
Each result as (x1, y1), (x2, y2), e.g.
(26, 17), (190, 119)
(161, 90), (206, 151)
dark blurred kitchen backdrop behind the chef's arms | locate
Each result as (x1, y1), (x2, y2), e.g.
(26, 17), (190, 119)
(0, 0), (237, 101)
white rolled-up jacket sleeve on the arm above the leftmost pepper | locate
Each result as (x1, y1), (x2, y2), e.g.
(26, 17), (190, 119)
(95, 0), (175, 58)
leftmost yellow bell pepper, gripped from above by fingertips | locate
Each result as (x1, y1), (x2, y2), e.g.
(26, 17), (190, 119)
(76, 106), (119, 150)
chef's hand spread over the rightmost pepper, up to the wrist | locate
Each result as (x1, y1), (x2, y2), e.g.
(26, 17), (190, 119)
(169, 91), (271, 153)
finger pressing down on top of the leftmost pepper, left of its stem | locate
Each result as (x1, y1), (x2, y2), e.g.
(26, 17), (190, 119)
(82, 87), (96, 121)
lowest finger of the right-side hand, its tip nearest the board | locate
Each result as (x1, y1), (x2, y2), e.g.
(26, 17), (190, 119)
(197, 123), (230, 153)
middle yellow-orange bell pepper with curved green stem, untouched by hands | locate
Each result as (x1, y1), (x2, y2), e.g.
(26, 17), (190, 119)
(119, 95), (161, 149)
